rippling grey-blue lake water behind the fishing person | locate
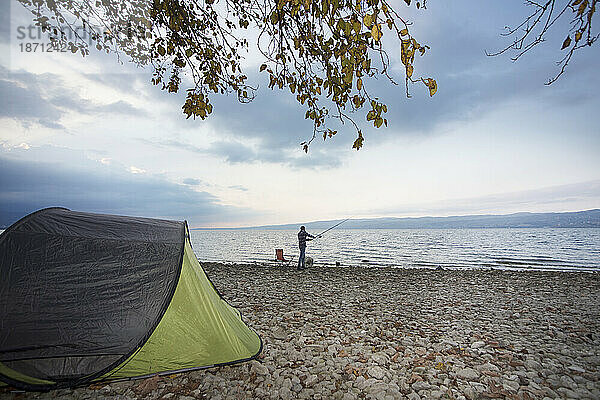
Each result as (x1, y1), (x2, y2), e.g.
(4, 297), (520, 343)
(191, 228), (600, 271)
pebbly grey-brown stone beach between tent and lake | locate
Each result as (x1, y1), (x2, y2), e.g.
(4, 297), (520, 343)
(0, 263), (600, 400)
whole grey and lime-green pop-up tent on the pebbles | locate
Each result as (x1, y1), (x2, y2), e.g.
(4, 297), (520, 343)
(0, 208), (262, 390)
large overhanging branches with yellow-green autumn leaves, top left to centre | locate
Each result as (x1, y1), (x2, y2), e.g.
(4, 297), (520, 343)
(19, 0), (437, 151)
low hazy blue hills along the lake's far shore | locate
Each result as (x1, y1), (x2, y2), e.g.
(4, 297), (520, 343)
(193, 209), (600, 230)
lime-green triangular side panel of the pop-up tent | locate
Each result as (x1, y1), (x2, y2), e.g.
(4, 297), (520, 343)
(106, 240), (262, 378)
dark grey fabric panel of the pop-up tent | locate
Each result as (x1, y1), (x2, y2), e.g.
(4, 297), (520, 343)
(0, 208), (187, 384)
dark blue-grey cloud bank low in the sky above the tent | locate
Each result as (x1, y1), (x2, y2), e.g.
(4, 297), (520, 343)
(0, 148), (255, 227)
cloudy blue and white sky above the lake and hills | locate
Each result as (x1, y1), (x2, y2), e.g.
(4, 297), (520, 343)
(0, 0), (600, 227)
